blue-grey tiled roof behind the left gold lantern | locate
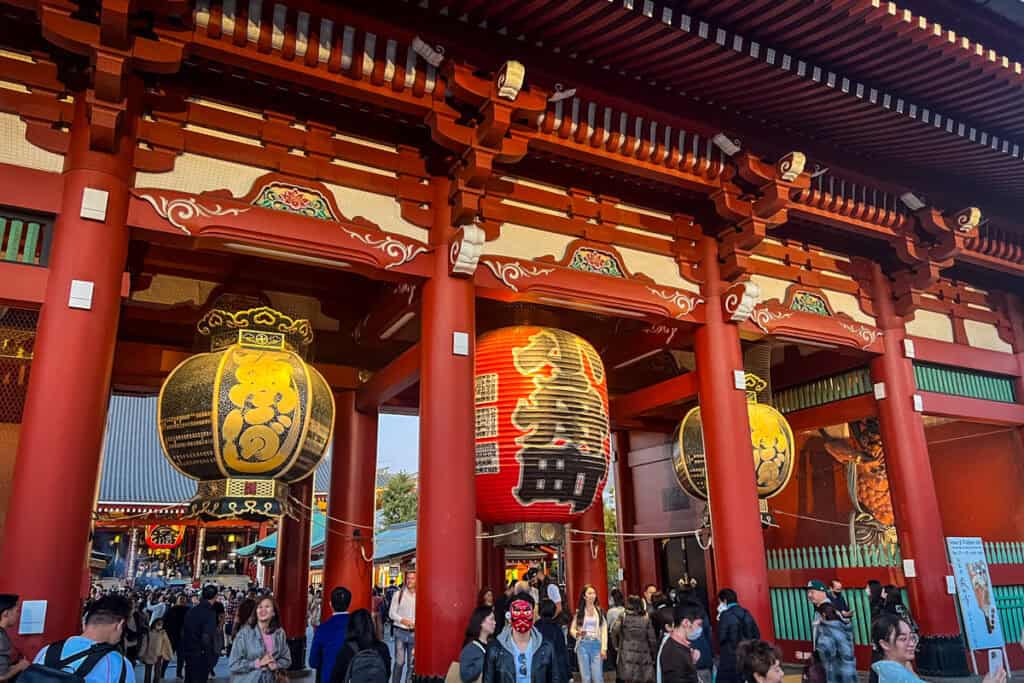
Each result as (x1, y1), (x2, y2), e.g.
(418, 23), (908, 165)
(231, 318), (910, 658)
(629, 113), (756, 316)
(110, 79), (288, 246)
(99, 395), (331, 505)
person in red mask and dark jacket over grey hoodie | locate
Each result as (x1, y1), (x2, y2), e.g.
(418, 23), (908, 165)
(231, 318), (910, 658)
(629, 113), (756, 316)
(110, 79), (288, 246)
(483, 593), (560, 683)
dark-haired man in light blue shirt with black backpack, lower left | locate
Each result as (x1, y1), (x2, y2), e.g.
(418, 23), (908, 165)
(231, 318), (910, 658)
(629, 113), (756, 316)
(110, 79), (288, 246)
(27, 595), (135, 683)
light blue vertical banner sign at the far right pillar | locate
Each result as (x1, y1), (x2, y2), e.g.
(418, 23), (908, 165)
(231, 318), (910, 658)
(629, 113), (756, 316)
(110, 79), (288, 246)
(946, 537), (1006, 650)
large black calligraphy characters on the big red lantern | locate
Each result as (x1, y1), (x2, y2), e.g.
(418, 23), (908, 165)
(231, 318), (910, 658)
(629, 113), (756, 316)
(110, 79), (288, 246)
(512, 330), (608, 512)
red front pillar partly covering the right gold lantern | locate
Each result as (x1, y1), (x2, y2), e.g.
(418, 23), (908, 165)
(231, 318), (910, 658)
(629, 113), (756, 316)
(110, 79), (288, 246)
(694, 238), (773, 640)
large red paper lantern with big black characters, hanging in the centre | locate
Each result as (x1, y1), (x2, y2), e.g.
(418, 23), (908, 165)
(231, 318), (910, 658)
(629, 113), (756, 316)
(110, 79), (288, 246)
(475, 326), (611, 524)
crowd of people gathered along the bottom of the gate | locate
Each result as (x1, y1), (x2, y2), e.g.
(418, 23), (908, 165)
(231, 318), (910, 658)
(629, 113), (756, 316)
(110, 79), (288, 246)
(0, 571), (1007, 683)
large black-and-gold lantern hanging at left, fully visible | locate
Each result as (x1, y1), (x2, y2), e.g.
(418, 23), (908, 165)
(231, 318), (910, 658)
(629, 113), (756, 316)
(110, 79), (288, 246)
(157, 297), (334, 517)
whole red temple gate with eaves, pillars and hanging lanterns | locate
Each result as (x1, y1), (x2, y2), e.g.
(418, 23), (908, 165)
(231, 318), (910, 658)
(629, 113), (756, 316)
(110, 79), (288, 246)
(0, 0), (1024, 681)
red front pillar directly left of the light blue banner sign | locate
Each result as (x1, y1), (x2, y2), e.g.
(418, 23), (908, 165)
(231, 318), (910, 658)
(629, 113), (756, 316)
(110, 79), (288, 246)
(871, 266), (959, 655)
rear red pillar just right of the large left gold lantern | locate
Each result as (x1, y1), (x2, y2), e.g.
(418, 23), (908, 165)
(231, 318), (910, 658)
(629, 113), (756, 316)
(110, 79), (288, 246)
(324, 391), (377, 611)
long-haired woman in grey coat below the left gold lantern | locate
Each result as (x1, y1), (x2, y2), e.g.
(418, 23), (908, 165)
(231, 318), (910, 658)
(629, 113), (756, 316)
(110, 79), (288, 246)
(228, 596), (292, 683)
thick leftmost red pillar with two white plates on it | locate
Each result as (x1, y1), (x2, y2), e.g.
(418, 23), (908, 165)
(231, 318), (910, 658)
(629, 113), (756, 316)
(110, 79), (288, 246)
(0, 92), (135, 652)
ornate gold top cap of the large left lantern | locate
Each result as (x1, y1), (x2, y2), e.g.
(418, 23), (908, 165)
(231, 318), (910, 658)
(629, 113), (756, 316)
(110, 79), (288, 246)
(196, 306), (313, 356)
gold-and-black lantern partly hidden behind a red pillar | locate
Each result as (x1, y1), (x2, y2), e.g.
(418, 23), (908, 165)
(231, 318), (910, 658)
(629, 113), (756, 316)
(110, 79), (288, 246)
(673, 373), (796, 525)
